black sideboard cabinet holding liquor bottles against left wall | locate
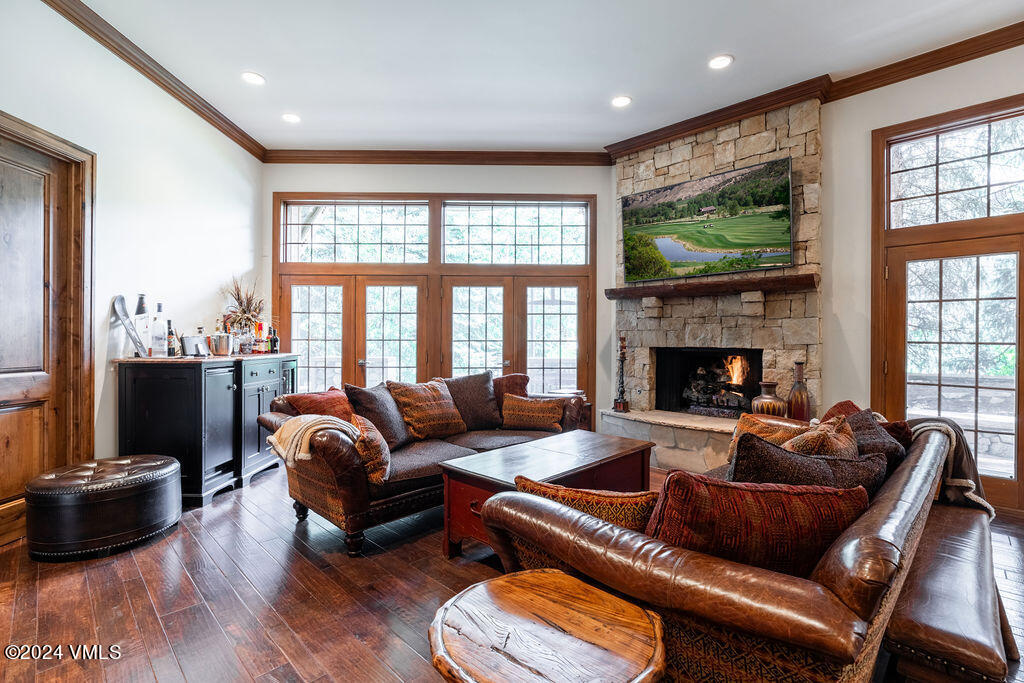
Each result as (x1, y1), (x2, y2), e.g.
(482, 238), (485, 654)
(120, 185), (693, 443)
(118, 353), (298, 505)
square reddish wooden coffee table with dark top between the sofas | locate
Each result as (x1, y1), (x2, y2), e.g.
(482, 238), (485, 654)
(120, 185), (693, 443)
(440, 429), (654, 557)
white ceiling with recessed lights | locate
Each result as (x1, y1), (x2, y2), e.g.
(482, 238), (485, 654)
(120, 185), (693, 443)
(86, 0), (1024, 151)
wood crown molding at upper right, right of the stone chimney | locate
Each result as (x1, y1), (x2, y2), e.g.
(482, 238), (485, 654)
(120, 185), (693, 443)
(825, 22), (1024, 102)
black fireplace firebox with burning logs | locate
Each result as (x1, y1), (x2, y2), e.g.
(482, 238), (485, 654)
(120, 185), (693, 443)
(654, 347), (763, 418)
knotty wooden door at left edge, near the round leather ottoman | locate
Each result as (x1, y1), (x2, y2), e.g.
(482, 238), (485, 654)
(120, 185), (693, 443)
(0, 132), (72, 543)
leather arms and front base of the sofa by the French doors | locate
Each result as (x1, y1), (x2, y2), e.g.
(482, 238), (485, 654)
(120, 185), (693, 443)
(258, 394), (589, 556)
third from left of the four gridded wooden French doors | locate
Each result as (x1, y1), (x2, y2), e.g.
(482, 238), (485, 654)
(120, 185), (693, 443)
(440, 275), (515, 377)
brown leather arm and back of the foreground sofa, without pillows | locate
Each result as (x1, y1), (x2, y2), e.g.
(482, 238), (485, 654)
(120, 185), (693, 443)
(482, 431), (949, 681)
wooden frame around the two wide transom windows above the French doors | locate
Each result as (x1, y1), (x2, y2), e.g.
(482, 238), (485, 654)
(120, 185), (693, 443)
(270, 191), (597, 399)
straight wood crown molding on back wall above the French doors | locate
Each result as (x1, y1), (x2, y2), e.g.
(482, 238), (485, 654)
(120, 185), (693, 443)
(263, 150), (614, 166)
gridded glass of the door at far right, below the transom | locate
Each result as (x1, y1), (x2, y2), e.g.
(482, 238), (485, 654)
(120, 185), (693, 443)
(906, 253), (1018, 479)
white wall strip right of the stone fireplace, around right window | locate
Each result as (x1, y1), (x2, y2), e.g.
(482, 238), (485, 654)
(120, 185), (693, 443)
(821, 47), (1024, 407)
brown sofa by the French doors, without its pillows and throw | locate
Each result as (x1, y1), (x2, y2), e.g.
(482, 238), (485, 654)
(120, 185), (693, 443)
(258, 385), (586, 555)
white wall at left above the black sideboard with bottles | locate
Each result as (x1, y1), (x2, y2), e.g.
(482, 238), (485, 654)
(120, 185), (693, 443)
(0, 0), (262, 457)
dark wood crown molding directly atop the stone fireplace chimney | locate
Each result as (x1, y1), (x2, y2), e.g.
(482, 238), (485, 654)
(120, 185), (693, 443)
(604, 74), (831, 159)
